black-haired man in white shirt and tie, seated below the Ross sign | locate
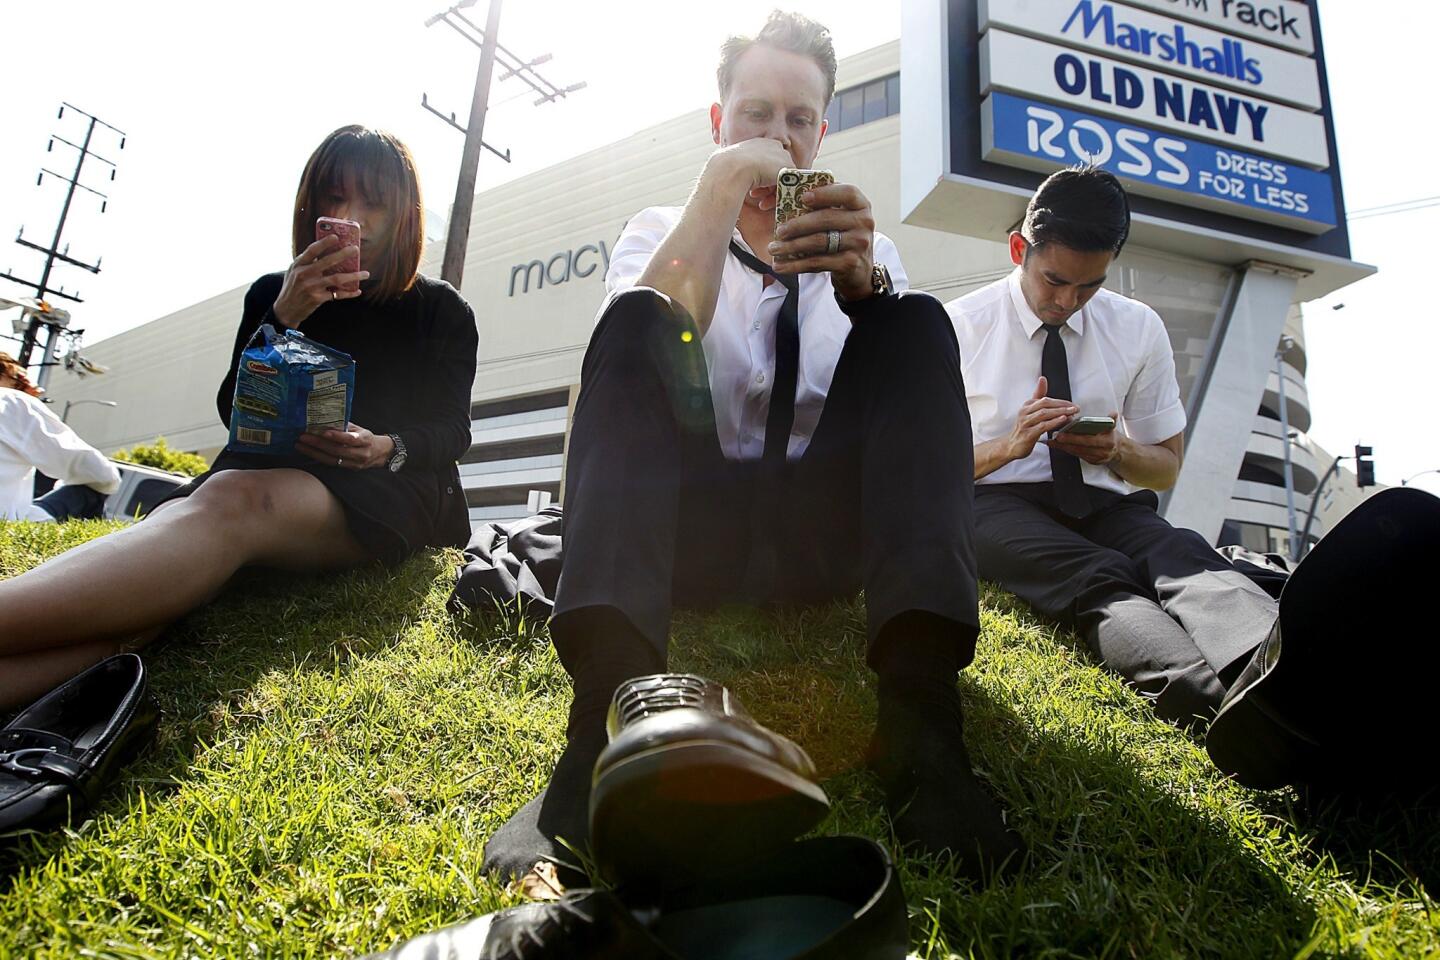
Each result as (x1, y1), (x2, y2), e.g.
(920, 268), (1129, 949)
(946, 167), (1324, 788)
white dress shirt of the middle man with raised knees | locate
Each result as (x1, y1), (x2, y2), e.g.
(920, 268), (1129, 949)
(602, 207), (909, 461)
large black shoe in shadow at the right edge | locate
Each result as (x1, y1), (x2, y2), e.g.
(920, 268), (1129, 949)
(1205, 488), (1440, 792)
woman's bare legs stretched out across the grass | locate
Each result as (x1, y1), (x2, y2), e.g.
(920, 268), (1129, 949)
(0, 469), (369, 704)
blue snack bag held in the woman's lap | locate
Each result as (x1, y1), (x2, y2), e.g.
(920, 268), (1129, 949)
(230, 324), (356, 453)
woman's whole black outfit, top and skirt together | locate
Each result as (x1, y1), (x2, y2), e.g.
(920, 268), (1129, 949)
(159, 273), (478, 561)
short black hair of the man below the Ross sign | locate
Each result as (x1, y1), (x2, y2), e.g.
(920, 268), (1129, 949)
(1020, 166), (1130, 253)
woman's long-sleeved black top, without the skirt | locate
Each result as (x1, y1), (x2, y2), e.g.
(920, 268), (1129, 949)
(215, 273), (478, 469)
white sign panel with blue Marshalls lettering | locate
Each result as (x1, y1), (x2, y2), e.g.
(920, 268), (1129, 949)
(979, 0), (1320, 111)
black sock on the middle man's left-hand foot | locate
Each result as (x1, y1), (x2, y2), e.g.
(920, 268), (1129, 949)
(482, 607), (665, 888)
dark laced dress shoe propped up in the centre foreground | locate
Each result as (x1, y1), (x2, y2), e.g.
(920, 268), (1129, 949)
(590, 674), (829, 888)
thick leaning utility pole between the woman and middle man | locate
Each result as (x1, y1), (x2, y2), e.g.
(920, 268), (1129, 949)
(420, 0), (585, 289)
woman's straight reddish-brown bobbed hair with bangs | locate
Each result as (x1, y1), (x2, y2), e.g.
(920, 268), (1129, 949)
(291, 124), (425, 299)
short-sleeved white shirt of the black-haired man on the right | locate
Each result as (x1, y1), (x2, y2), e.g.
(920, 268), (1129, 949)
(945, 268), (1185, 494)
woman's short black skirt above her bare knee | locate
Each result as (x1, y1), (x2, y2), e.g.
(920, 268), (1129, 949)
(160, 449), (469, 564)
